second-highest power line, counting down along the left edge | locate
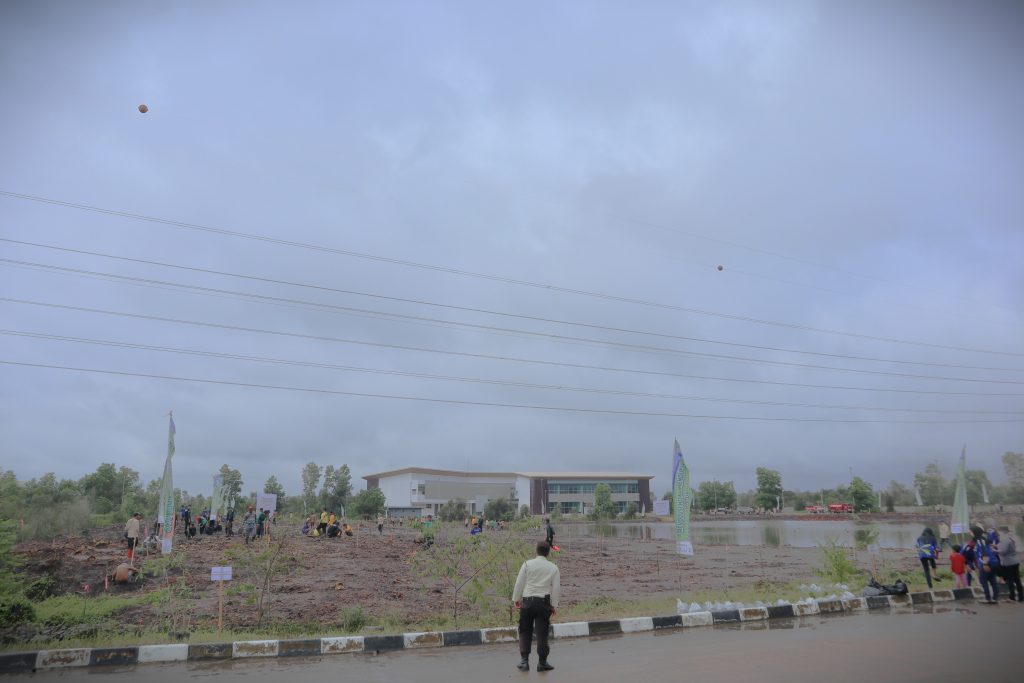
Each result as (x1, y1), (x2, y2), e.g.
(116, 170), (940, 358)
(0, 238), (1024, 373)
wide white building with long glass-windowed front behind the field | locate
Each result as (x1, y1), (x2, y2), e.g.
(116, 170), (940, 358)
(362, 467), (653, 515)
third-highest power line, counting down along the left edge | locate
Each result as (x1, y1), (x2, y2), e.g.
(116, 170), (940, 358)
(0, 258), (1024, 384)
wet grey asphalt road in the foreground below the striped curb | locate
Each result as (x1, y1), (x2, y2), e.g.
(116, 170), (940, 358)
(25, 603), (1024, 683)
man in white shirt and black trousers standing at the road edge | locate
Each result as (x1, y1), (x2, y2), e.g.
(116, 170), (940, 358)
(512, 541), (561, 671)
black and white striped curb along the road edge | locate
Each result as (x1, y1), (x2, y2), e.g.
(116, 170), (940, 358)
(0, 587), (984, 674)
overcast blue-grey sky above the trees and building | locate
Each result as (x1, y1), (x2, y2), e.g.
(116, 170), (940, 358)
(0, 1), (1024, 501)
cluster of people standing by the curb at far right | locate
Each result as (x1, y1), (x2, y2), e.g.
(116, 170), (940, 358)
(918, 522), (1024, 604)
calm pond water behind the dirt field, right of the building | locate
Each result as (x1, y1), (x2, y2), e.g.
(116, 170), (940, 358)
(555, 519), (1024, 548)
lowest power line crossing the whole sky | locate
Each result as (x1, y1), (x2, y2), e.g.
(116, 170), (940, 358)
(0, 359), (1024, 425)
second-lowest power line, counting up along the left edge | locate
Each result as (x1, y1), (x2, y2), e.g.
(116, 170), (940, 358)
(6, 330), (1024, 417)
